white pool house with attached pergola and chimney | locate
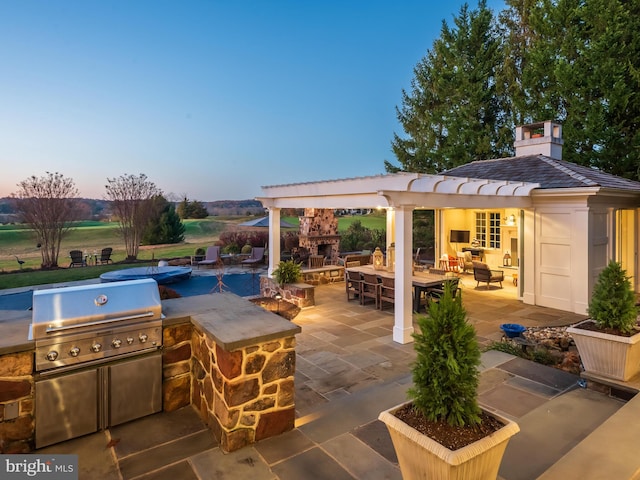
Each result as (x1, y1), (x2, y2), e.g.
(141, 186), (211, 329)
(259, 121), (640, 343)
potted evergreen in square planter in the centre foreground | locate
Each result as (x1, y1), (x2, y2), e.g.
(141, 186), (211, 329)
(379, 282), (520, 480)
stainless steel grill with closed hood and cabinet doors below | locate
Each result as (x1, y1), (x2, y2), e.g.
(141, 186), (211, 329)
(29, 279), (162, 448)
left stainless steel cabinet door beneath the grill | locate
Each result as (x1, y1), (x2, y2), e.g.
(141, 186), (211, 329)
(35, 369), (99, 448)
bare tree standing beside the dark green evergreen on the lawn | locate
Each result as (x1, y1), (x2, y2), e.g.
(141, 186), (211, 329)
(105, 173), (162, 260)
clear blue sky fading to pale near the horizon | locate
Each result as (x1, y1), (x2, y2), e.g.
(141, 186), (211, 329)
(0, 0), (504, 201)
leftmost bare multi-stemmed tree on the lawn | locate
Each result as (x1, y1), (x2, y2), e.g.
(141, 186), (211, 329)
(14, 172), (78, 268)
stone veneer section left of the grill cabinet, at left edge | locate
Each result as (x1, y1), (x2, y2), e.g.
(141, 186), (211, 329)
(0, 351), (35, 454)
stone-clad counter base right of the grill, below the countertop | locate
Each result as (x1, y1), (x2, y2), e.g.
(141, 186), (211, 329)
(192, 327), (296, 452)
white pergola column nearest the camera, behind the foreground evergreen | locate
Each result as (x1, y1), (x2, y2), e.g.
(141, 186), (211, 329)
(393, 206), (414, 344)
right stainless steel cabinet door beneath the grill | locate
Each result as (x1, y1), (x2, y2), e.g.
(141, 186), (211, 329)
(107, 351), (162, 426)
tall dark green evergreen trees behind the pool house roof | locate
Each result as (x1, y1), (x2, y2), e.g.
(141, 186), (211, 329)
(385, 0), (640, 180)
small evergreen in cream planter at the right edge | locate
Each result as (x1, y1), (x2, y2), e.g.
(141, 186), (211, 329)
(567, 261), (640, 382)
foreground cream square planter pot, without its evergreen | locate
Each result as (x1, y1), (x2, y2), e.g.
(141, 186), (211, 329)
(378, 402), (520, 480)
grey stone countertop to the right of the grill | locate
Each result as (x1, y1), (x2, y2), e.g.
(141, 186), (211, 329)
(162, 293), (301, 351)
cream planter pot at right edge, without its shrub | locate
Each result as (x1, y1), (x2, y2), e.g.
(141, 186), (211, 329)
(567, 320), (640, 382)
